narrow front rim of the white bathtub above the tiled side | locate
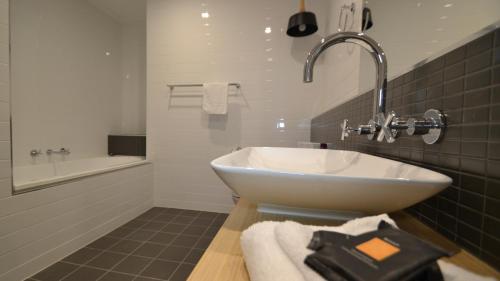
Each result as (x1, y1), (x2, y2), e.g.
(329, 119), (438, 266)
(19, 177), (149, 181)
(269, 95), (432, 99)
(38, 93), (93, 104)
(12, 159), (153, 195)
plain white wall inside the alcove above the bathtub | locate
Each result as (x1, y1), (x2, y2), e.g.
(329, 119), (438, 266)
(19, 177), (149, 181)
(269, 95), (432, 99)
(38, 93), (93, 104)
(10, 0), (146, 166)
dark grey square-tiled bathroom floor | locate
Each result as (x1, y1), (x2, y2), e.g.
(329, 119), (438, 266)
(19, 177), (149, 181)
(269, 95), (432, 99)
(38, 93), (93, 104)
(27, 207), (219, 281)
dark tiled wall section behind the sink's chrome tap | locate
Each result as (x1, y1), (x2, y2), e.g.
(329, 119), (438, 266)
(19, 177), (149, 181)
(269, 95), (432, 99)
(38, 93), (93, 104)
(311, 29), (500, 269)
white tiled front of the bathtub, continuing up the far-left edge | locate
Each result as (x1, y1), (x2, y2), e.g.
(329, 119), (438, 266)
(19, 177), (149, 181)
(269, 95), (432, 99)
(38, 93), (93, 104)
(0, 0), (153, 281)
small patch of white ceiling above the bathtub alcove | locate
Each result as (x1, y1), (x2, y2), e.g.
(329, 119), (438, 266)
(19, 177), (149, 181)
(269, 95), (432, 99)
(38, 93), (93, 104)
(87, 0), (147, 23)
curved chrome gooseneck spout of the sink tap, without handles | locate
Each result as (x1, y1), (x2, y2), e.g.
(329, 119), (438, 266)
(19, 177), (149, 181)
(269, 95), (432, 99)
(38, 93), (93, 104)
(304, 32), (387, 117)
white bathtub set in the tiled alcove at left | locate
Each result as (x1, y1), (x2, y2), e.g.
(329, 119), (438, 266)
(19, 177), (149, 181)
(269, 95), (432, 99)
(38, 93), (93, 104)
(13, 156), (148, 192)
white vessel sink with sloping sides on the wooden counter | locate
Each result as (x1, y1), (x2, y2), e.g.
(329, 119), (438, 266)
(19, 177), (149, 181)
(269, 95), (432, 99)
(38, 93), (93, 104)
(211, 147), (451, 219)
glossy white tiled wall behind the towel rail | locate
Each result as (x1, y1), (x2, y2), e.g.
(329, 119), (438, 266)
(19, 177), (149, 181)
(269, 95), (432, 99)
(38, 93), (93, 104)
(147, 0), (358, 211)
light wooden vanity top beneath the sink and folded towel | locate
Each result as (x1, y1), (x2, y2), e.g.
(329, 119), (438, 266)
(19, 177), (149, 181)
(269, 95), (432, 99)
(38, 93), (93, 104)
(188, 199), (500, 281)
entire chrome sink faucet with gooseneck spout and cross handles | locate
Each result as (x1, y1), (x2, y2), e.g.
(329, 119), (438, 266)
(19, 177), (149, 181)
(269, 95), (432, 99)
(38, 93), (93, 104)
(304, 32), (446, 144)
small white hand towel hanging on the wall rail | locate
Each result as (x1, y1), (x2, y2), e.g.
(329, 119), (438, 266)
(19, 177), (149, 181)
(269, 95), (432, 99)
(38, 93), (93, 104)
(203, 82), (229, 115)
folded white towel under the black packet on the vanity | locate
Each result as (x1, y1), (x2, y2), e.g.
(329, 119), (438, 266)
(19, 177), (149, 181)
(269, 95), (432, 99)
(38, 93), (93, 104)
(241, 214), (495, 281)
